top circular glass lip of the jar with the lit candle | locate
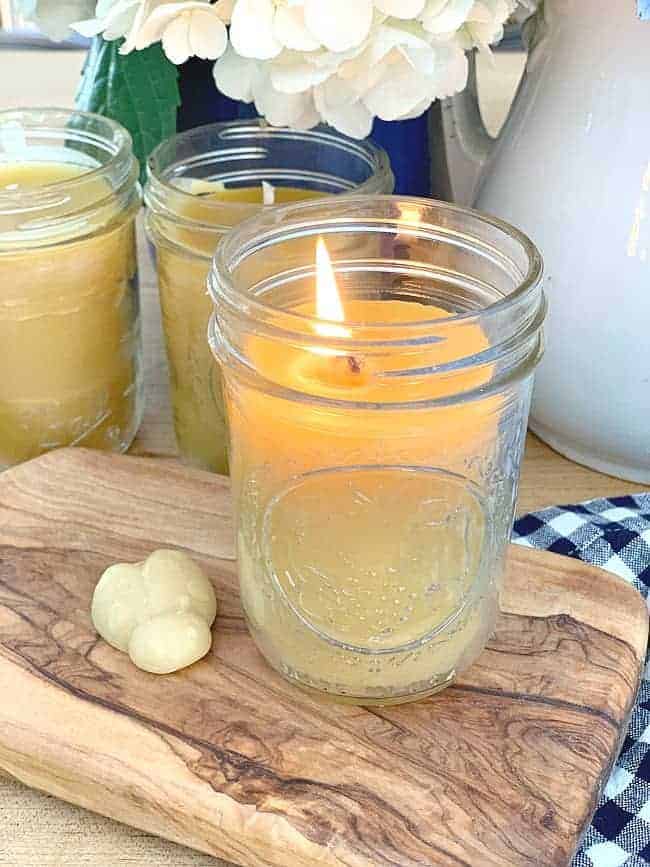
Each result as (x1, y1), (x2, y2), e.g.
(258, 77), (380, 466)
(208, 193), (544, 334)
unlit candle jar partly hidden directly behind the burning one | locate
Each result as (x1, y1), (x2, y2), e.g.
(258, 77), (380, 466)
(145, 120), (394, 473)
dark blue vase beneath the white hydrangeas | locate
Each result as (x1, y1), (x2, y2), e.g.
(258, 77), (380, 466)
(177, 58), (432, 196)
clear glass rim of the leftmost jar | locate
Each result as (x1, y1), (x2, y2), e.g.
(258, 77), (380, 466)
(0, 107), (135, 210)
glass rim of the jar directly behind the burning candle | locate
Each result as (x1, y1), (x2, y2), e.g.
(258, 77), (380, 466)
(145, 117), (392, 231)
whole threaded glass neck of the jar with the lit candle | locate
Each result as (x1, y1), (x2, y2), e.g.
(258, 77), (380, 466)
(208, 195), (546, 409)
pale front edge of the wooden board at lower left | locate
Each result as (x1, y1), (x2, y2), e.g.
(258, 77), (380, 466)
(0, 648), (344, 867)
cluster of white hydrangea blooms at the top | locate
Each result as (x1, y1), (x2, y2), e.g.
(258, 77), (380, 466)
(19, 0), (520, 138)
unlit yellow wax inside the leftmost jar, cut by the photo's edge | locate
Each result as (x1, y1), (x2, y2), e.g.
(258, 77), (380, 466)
(0, 161), (139, 466)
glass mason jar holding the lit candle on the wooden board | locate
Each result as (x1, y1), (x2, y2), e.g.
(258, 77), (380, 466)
(209, 196), (546, 704)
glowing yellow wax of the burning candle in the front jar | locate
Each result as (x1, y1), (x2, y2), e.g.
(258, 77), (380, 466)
(220, 249), (498, 697)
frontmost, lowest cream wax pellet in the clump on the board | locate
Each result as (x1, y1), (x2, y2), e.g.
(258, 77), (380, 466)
(129, 611), (212, 674)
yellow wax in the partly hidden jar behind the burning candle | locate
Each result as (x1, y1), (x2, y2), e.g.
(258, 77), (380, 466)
(157, 179), (330, 473)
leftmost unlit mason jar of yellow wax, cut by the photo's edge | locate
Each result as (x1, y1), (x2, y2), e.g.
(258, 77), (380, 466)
(0, 109), (142, 468)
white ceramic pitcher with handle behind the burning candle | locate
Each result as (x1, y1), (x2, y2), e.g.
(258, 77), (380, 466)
(442, 0), (650, 482)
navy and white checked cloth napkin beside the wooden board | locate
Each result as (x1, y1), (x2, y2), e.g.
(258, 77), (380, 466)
(513, 494), (650, 867)
